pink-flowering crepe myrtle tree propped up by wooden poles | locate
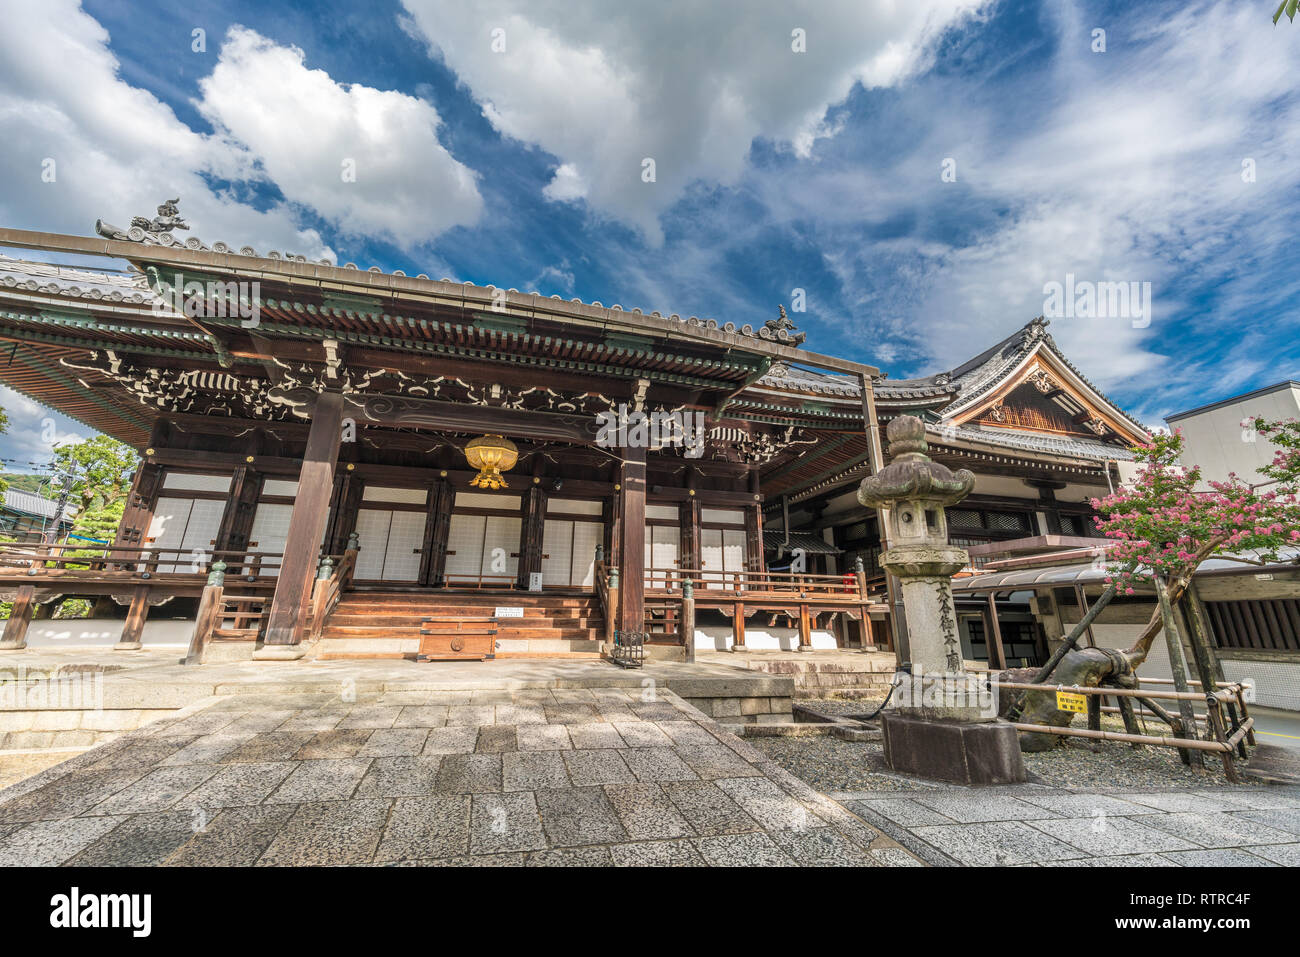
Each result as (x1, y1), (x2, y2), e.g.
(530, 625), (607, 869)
(1002, 419), (1300, 750)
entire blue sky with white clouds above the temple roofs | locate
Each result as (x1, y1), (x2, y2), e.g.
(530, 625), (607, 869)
(0, 0), (1300, 460)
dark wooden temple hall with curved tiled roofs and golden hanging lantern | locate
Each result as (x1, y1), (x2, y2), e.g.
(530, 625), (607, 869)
(0, 208), (1147, 663)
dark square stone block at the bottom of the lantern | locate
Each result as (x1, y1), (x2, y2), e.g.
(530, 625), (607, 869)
(880, 710), (1024, 784)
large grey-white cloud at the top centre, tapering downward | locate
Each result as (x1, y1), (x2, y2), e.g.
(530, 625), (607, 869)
(402, 0), (980, 242)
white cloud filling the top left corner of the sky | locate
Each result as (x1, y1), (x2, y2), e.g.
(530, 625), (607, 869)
(0, 0), (333, 257)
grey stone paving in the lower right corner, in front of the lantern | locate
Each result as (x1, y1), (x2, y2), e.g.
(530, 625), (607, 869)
(831, 784), (1300, 867)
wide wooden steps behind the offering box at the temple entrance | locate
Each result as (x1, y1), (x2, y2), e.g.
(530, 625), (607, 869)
(316, 590), (605, 659)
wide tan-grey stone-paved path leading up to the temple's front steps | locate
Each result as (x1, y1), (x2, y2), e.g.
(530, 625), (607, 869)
(0, 688), (919, 866)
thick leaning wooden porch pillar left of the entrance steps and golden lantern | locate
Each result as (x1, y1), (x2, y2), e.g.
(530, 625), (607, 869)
(254, 393), (343, 659)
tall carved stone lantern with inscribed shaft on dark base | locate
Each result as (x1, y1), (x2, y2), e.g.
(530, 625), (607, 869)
(858, 415), (1024, 784)
